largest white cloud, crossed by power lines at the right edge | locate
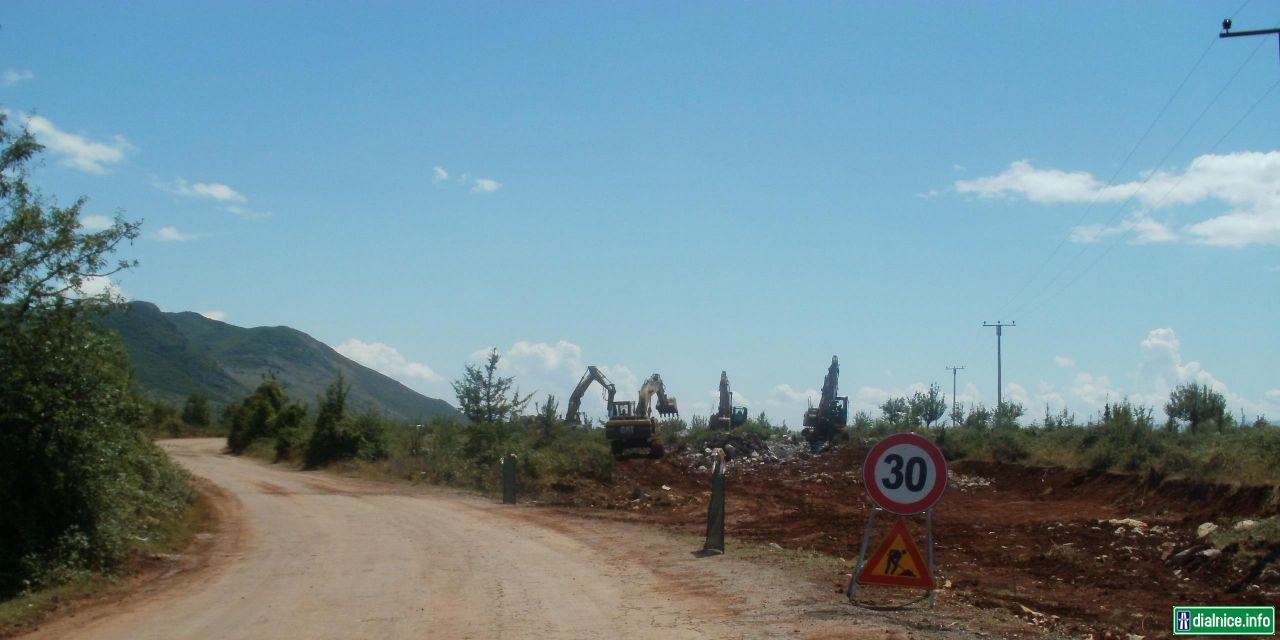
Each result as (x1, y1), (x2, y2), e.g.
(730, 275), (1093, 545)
(955, 151), (1280, 247)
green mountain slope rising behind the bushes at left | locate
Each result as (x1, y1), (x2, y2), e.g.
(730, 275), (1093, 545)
(102, 302), (462, 421)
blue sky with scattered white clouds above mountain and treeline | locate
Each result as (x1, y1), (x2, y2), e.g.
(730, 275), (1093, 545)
(0, 0), (1280, 426)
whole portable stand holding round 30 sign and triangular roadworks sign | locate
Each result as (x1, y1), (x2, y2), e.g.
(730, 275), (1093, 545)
(845, 434), (947, 607)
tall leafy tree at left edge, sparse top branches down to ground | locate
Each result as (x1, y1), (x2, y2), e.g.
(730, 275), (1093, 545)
(0, 113), (193, 599)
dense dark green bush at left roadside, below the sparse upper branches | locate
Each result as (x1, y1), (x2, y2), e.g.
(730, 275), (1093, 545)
(0, 311), (193, 595)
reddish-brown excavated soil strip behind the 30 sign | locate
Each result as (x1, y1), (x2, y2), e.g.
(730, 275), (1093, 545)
(537, 443), (1280, 637)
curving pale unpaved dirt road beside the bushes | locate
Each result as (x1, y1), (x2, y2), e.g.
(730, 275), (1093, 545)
(29, 439), (993, 640)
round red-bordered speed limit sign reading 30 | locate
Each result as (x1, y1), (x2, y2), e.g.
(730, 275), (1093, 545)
(863, 434), (947, 516)
